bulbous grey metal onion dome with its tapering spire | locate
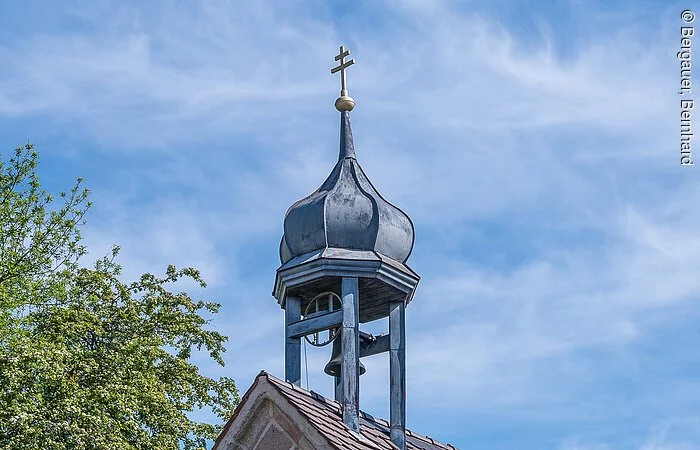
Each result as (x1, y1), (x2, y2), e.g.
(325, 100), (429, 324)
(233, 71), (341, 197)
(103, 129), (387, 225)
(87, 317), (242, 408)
(280, 52), (414, 264)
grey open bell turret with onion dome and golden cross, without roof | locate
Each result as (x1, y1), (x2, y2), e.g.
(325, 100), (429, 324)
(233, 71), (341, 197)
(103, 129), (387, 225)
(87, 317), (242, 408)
(273, 46), (420, 449)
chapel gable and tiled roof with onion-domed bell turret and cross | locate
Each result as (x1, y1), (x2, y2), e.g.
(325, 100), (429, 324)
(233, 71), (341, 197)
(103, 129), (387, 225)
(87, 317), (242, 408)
(212, 46), (456, 450)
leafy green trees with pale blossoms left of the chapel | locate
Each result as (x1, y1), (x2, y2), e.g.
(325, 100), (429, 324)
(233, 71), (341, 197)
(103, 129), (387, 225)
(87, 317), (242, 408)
(0, 145), (239, 450)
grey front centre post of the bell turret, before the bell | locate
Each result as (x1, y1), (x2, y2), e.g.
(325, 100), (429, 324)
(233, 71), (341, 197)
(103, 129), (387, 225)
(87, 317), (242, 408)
(340, 277), (360, 433)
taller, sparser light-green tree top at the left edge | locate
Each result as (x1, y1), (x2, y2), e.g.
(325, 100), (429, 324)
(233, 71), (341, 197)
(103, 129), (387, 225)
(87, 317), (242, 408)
(0, 145), (91, 330)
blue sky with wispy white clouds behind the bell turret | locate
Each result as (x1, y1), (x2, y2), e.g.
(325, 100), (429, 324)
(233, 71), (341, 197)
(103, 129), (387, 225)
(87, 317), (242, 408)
(0, 0), (700, 450)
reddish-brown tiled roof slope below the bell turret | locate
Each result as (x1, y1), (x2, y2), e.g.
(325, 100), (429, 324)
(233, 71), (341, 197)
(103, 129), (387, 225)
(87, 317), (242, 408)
(239, 371), (456, 450)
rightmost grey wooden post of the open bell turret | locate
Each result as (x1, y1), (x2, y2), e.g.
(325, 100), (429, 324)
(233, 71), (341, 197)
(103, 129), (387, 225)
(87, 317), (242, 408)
(389, 301), (406, 450)
